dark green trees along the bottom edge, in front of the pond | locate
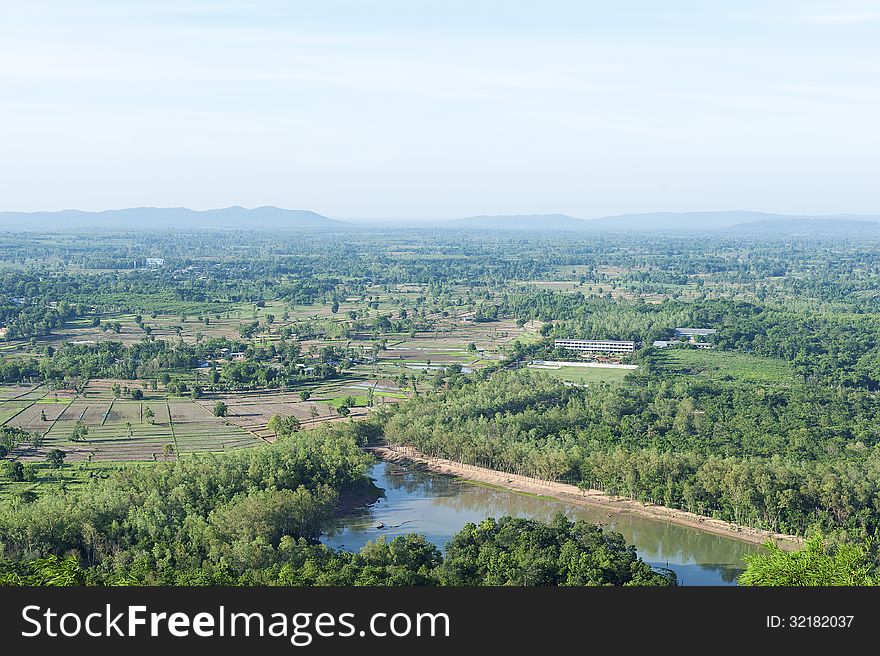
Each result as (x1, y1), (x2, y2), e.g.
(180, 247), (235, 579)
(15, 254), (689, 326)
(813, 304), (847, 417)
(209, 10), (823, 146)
(0, 507), (676, 586)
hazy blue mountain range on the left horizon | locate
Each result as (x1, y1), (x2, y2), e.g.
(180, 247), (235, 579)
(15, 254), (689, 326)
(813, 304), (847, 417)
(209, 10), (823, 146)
(0, 206), (347, 231)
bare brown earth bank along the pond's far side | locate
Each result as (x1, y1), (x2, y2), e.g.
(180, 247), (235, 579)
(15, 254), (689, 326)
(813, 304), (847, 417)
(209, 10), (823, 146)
(368, 446), (803, 550)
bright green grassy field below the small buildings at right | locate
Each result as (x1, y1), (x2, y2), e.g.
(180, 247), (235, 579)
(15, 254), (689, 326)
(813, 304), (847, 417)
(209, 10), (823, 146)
(657, 348), (793, 383)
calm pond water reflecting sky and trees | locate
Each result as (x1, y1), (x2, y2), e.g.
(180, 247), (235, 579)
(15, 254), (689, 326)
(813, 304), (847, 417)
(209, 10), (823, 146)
(323, 462), (759, 585)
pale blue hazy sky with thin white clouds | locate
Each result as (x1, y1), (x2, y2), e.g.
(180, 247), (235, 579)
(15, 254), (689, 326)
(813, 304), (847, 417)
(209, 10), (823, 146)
(0, 0), (880, 219)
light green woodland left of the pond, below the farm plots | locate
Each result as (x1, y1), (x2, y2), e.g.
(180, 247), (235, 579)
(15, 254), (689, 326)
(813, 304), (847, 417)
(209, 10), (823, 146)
(0, 426), (370, 583)
